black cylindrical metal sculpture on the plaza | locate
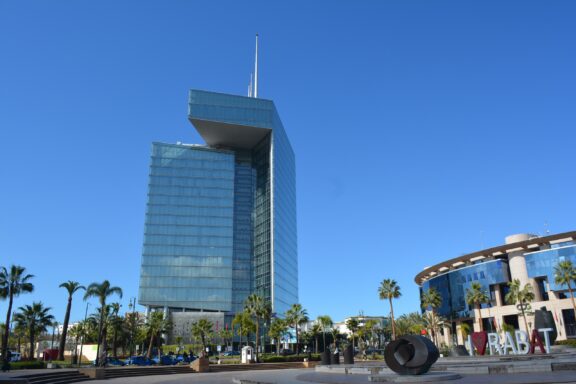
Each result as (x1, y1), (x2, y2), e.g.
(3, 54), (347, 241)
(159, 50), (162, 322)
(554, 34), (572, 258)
(384, 336), (440, 375)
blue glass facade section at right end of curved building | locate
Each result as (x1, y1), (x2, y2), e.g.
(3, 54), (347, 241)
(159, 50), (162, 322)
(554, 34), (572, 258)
(524, 242), (576, 291)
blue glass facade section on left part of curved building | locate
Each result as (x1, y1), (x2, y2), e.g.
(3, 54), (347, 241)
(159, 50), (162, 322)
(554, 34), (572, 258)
(422, 260), (510, 320)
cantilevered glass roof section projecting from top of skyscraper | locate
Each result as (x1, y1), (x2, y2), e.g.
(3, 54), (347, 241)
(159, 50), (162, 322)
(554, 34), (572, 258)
(188, 89), (278, 149)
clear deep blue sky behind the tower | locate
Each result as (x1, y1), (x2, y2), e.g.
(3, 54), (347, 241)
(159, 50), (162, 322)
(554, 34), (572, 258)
(0, 0), (576, 328)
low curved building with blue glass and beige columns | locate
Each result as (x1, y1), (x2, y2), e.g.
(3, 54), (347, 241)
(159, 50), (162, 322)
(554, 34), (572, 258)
(415, 231), (576, 344)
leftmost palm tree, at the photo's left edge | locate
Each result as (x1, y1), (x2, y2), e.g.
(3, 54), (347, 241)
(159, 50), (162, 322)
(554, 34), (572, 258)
(0, 265), (34, 365)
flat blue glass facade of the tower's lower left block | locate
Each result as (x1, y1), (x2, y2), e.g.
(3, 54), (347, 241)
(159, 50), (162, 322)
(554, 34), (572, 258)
(139, 143), (234, 311)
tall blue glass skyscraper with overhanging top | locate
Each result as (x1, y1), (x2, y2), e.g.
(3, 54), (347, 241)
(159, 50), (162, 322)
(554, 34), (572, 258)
(139, 90), (298, 336)
